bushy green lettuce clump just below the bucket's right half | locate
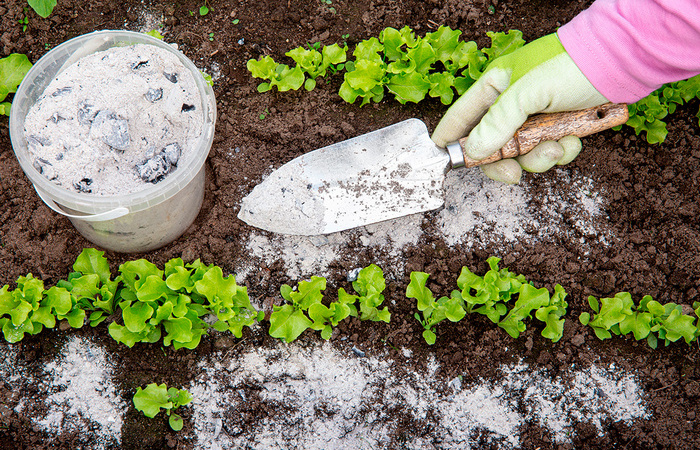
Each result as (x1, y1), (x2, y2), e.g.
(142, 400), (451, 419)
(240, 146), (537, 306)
(109, 258), (263, 350)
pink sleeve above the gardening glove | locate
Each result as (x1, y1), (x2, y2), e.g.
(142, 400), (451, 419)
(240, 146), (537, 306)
(557, 0), (700, 103)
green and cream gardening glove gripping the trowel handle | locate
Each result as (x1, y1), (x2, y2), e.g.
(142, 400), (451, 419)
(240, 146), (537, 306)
(432, 34), (608, 184)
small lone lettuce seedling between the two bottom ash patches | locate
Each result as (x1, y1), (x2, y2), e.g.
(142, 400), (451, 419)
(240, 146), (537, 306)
(133, 383), (192, 431)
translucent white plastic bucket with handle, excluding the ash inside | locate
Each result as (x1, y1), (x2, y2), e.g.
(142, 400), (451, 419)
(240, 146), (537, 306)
(10, 31), (216, 252)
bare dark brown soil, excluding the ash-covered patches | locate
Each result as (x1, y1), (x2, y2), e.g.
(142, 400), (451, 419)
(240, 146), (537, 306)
(0, 0), (700, 449)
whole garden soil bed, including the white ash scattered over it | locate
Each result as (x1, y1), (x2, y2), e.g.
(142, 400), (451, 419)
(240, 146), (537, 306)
(0, 0), (700, 449)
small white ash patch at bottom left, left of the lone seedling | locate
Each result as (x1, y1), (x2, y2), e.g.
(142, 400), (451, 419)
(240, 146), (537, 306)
(36, 337), (127, 448)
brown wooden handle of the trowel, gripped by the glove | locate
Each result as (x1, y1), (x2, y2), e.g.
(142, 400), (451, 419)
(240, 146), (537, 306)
(459, 103), (629, 167)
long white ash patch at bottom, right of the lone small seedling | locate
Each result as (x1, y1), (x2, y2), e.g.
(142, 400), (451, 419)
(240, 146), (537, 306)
(188, 343), (649, 450)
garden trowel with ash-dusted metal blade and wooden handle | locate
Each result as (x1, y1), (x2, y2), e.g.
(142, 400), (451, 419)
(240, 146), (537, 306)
(238, 103), (628, 236)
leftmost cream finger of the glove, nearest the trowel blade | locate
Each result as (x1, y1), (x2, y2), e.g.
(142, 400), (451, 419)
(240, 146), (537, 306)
(431, 69), (510, 148)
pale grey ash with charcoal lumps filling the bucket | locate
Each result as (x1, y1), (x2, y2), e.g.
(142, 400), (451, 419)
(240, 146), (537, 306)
(24, 44), (203, 195)
